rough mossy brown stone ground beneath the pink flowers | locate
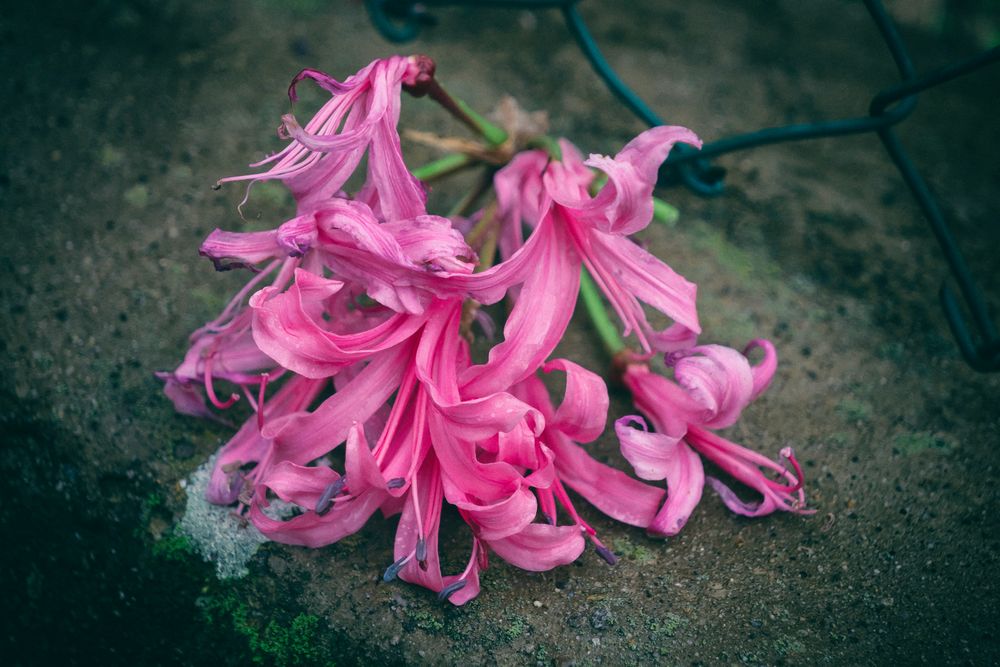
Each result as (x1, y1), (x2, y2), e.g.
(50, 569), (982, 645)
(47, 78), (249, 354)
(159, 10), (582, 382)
(0, 0), (1000, 665)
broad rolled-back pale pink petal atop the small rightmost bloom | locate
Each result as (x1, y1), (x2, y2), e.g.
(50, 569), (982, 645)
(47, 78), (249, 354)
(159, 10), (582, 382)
(668, 345), (754, 428)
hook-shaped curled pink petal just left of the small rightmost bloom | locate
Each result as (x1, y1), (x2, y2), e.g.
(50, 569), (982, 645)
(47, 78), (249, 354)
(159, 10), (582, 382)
(542, 359), (608, 442)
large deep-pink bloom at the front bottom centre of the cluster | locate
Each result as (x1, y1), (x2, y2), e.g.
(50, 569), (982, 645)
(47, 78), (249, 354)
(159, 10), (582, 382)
(242, 292), (636, 604)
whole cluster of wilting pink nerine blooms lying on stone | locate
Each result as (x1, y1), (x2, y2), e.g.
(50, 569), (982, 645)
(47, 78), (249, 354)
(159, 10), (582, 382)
(160, 57), (804, 604)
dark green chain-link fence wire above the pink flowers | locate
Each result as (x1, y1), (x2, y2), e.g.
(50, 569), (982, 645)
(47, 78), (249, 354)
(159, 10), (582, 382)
(365, 0), (1000, 372)
